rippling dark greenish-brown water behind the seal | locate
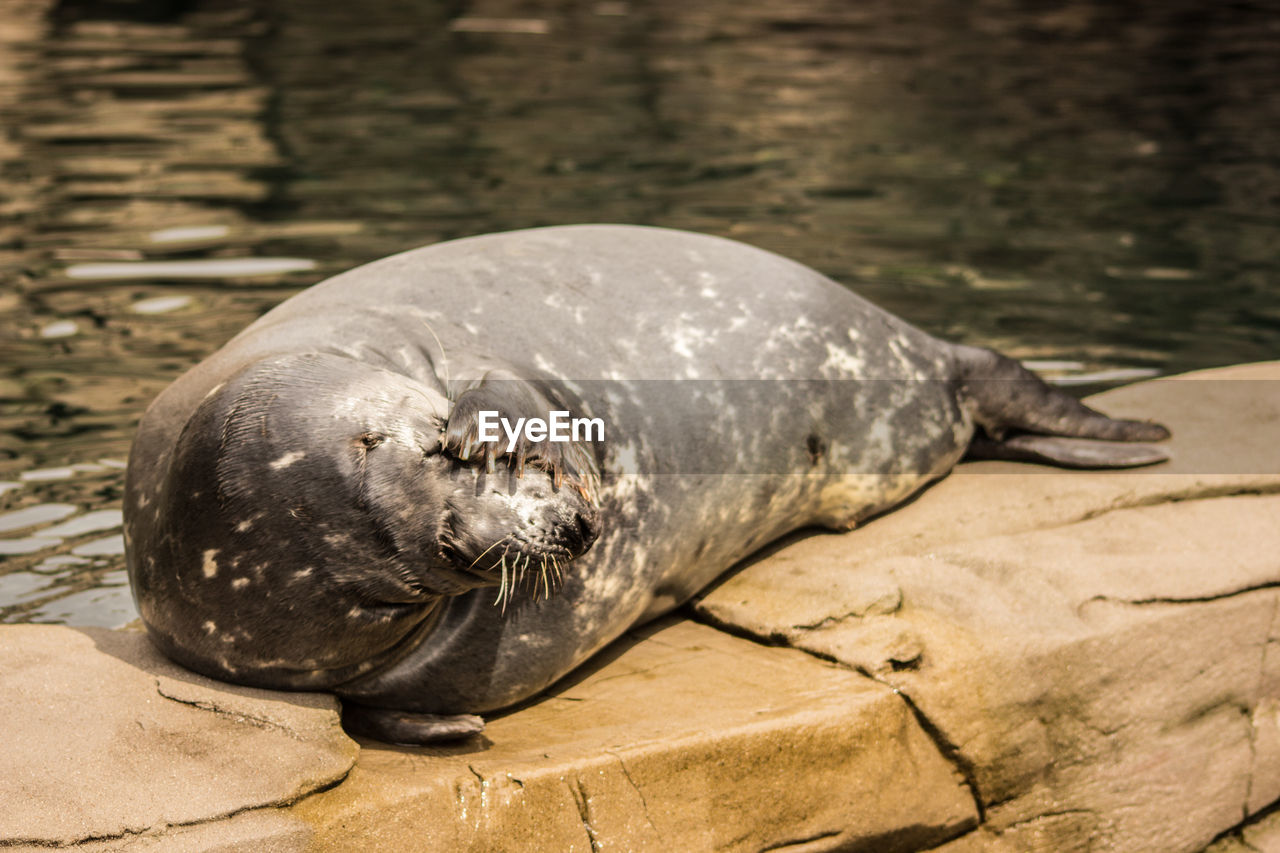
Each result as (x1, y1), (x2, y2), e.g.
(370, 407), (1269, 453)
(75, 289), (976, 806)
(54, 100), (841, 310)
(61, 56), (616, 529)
(0, 0), (1280, 625)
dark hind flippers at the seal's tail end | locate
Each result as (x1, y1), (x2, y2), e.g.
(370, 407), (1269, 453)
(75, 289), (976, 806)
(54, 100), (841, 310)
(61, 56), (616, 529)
(955, 346), (1169, 467)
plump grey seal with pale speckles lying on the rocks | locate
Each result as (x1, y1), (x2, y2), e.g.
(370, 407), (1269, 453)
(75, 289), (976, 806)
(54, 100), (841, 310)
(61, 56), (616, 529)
(124, 225), (1169, 743)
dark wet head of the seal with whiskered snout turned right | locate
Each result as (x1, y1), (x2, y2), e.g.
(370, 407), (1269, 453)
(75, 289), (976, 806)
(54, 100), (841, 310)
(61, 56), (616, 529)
(129, 353), (599, 688)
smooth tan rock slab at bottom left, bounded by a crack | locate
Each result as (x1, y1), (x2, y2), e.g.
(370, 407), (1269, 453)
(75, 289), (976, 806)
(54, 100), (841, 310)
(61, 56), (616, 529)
(0, 625), (357, 845)
